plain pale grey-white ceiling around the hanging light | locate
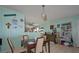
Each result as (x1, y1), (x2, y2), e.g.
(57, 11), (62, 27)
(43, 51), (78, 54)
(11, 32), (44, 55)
(1, 5), (79, 20)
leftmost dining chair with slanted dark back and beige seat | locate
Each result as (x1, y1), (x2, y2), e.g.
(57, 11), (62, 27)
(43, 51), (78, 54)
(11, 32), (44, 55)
(7, 38), (27, 53)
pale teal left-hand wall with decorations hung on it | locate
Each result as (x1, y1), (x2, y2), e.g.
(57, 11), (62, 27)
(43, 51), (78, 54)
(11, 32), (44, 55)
(0, 6), (40, 52)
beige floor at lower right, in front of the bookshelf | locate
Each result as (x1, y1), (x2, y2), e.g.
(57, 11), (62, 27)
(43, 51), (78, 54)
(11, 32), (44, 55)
(50, 43), (79, 53)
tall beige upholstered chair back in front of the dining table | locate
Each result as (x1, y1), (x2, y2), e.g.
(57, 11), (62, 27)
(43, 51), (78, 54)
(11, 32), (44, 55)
(36, 37), (44, 53)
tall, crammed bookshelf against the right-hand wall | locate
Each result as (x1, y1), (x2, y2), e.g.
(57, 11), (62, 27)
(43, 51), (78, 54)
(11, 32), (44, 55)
(61, 22), (73, 43)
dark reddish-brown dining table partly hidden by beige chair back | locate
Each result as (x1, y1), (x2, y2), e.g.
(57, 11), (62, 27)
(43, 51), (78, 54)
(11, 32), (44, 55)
(21, 39), (50, 53)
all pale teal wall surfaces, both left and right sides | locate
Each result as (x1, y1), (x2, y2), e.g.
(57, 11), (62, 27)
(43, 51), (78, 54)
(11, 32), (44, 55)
(0, 6), (79, 52)
